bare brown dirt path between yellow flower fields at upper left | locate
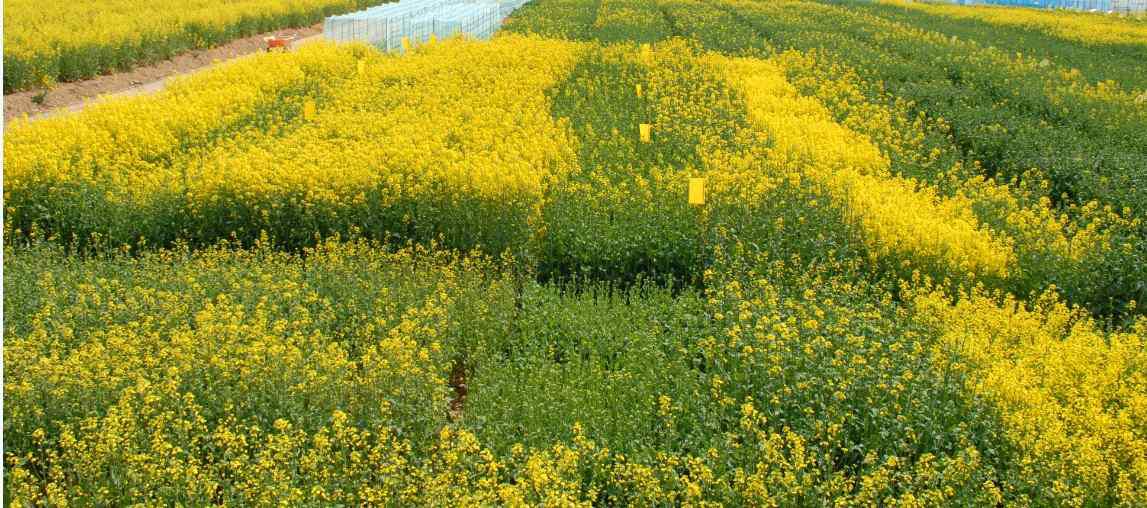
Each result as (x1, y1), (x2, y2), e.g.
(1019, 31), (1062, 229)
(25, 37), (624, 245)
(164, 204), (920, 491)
(3, 23), (322, 120)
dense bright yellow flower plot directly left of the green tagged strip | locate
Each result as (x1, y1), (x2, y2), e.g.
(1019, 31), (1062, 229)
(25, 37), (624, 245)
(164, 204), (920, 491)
(173, 37), (579, 247)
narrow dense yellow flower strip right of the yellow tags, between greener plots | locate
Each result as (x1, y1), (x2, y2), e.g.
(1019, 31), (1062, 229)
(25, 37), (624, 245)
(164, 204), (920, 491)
(711, 56), (1014, 282)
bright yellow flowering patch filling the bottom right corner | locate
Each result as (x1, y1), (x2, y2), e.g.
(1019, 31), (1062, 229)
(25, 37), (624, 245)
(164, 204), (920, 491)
(913, 287), (1147, 506)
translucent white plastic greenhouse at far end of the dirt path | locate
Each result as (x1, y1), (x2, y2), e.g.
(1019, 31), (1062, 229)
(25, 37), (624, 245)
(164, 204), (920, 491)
(322, 0), (529, 52)
